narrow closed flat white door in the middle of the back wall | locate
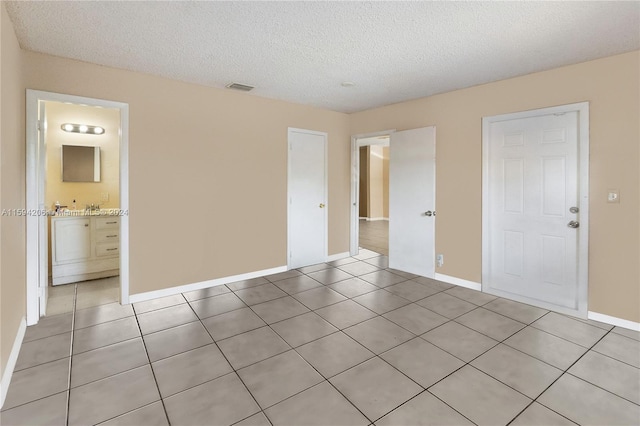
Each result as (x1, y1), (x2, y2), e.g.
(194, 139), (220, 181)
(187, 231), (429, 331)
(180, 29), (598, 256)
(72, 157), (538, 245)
(288, 129), (327, 269)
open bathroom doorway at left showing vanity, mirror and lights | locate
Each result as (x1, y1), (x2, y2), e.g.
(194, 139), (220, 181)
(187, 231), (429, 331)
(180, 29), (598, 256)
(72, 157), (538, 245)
(27, 90), (129, 325)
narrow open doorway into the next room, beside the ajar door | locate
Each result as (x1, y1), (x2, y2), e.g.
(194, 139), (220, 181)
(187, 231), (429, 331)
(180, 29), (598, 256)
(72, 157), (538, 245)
(350, 130), (393, 256)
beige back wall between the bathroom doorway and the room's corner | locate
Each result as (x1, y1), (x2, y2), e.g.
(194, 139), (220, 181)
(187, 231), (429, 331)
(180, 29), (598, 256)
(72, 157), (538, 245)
(23, 52), (350, 294)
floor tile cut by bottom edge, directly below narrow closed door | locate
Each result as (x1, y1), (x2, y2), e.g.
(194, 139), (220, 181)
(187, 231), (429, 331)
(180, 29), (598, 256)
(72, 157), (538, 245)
(266, 382), (369, 426)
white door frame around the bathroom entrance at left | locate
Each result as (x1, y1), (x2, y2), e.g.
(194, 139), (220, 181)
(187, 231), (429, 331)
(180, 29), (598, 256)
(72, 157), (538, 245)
(26, 89), (129, 325)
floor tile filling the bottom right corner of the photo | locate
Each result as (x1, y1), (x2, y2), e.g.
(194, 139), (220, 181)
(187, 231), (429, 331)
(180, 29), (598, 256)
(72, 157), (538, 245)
(538, 374), (640, 425)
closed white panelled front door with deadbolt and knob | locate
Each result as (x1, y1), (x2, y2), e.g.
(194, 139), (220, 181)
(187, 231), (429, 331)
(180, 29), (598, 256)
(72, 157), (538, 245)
(482, 105), (587, 312)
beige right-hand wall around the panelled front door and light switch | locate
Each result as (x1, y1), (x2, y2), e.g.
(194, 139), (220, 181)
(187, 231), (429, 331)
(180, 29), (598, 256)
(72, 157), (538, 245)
(351, 51), (640, 322)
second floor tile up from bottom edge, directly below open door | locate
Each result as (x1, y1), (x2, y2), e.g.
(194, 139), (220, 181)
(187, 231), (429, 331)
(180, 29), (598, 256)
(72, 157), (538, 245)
(380, 338), (464, 389)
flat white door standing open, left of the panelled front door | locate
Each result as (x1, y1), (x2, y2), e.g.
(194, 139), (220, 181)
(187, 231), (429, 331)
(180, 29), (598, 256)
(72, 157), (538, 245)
(389, 127), (436, 278)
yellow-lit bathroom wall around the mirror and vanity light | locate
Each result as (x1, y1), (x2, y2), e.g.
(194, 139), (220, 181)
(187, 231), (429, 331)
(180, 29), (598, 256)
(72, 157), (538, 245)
(45, 102), (120, 209)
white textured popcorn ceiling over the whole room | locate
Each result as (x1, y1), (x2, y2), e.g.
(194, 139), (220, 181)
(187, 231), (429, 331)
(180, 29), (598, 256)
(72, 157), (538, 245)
(3, 1), (640, 112)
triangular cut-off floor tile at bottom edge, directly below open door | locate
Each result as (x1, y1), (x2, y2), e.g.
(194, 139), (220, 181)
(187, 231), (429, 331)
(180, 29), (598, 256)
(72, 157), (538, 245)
(376, 392), (473, 426)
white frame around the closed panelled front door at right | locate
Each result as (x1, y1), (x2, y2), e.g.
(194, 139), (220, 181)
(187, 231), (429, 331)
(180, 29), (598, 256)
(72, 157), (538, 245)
(482, 102), (589, 318)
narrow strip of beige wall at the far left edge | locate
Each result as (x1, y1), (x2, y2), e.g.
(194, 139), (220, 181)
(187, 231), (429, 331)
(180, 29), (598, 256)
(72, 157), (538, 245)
(0, 4), (26, 382)
